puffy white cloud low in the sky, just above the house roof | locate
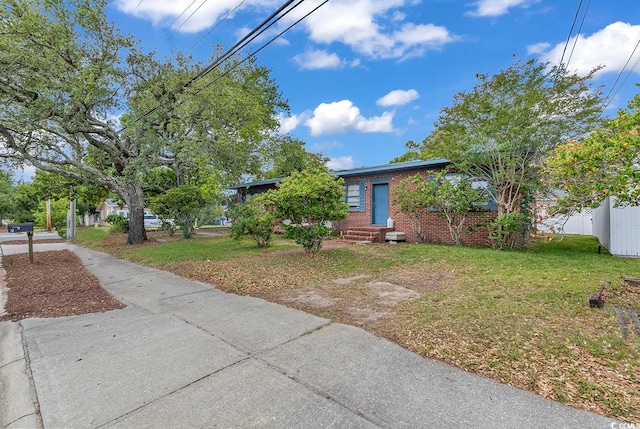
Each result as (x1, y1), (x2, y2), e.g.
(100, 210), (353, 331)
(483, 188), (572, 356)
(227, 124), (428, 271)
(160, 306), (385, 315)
(305, 100), (393, 136)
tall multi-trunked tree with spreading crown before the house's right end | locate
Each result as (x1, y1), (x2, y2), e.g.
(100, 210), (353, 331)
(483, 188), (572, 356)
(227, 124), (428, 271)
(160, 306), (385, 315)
(421, 60), (602, 247)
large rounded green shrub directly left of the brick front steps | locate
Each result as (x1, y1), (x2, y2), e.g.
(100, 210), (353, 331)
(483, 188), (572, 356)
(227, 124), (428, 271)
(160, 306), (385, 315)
(268, 169), (347, 253)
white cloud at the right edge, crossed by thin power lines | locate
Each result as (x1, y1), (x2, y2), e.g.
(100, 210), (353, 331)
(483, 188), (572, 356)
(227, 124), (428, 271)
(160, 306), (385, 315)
(541, 22), (640, 74)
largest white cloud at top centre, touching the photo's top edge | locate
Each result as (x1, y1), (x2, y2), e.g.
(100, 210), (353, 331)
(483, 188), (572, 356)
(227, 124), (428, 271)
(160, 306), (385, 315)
(289, 0), (458, 58)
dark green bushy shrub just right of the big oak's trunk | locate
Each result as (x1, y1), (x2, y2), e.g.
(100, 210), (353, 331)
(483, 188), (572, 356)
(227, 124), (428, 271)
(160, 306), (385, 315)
(149, 185), (205, 238)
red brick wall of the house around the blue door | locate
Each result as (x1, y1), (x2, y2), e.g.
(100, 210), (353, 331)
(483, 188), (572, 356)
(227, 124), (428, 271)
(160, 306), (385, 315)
(333, 171), (497, 246)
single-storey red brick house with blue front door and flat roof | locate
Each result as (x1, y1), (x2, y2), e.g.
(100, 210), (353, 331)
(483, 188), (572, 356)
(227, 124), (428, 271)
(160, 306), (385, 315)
(233, 159), (496, 245)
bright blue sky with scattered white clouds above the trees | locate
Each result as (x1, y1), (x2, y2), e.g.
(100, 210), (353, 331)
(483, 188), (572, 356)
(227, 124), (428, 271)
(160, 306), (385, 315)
(84, 0), (640, 169)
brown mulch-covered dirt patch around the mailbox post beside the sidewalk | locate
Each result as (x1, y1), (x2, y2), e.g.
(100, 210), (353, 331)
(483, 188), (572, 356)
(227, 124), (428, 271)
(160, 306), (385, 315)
(0, 249), (125, 322)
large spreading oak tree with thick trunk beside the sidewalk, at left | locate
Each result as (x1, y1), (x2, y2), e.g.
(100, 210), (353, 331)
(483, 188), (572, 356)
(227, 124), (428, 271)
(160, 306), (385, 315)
(0, 0), (286, 243)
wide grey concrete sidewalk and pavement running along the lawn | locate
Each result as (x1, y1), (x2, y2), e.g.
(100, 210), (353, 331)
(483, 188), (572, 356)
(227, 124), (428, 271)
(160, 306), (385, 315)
(0, 243), (614, 428)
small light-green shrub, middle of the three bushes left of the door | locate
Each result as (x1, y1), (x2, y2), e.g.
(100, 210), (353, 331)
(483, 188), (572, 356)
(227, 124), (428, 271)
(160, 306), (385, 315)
(229, 194), (275, 248)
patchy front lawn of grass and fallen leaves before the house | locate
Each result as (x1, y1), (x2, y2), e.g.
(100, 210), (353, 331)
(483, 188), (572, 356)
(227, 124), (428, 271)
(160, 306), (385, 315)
(77, 229), (640, 423)
